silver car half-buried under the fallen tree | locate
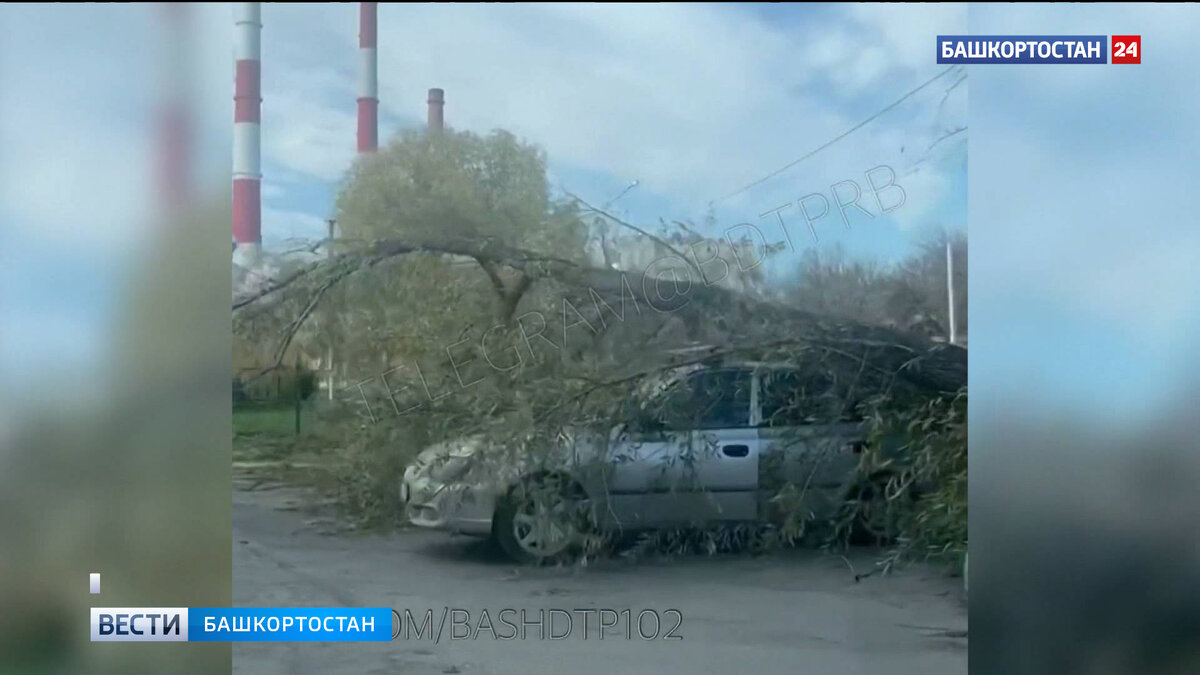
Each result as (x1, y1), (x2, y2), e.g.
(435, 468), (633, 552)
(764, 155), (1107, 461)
(401, 363), (883, 561)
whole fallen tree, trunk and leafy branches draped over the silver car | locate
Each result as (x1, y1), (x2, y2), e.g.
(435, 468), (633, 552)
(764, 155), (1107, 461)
(234, 228), (966, 561)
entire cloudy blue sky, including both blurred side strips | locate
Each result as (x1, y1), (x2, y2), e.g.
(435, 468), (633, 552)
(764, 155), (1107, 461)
(0, 4), (1200, 427)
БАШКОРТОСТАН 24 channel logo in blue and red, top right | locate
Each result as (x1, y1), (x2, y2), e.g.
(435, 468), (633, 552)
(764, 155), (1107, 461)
(937, 35), (1141, 65)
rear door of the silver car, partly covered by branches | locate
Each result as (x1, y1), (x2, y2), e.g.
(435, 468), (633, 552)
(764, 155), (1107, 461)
(755, 368), (866, 510)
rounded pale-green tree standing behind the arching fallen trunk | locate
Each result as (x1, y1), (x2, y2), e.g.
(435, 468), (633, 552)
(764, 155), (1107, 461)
(309, 130), (586, 371)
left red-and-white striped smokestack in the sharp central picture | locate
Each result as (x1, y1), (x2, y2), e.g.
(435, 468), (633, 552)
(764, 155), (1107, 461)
(233, 2), (263, 263)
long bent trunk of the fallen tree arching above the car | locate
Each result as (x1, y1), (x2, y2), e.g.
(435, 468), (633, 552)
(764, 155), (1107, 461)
(233, 234), (966, 393)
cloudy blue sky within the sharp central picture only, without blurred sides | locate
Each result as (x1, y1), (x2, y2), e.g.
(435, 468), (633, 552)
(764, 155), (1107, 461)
(248, 5), (966, 259)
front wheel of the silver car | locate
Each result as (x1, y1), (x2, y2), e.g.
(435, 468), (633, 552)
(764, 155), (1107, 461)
(492, 477), (584, 562)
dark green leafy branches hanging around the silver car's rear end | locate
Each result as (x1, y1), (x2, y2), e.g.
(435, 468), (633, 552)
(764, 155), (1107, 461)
(626, 389), (967, 564)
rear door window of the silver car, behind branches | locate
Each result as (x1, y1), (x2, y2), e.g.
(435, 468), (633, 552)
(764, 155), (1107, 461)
(761, 369), (860, 426)
